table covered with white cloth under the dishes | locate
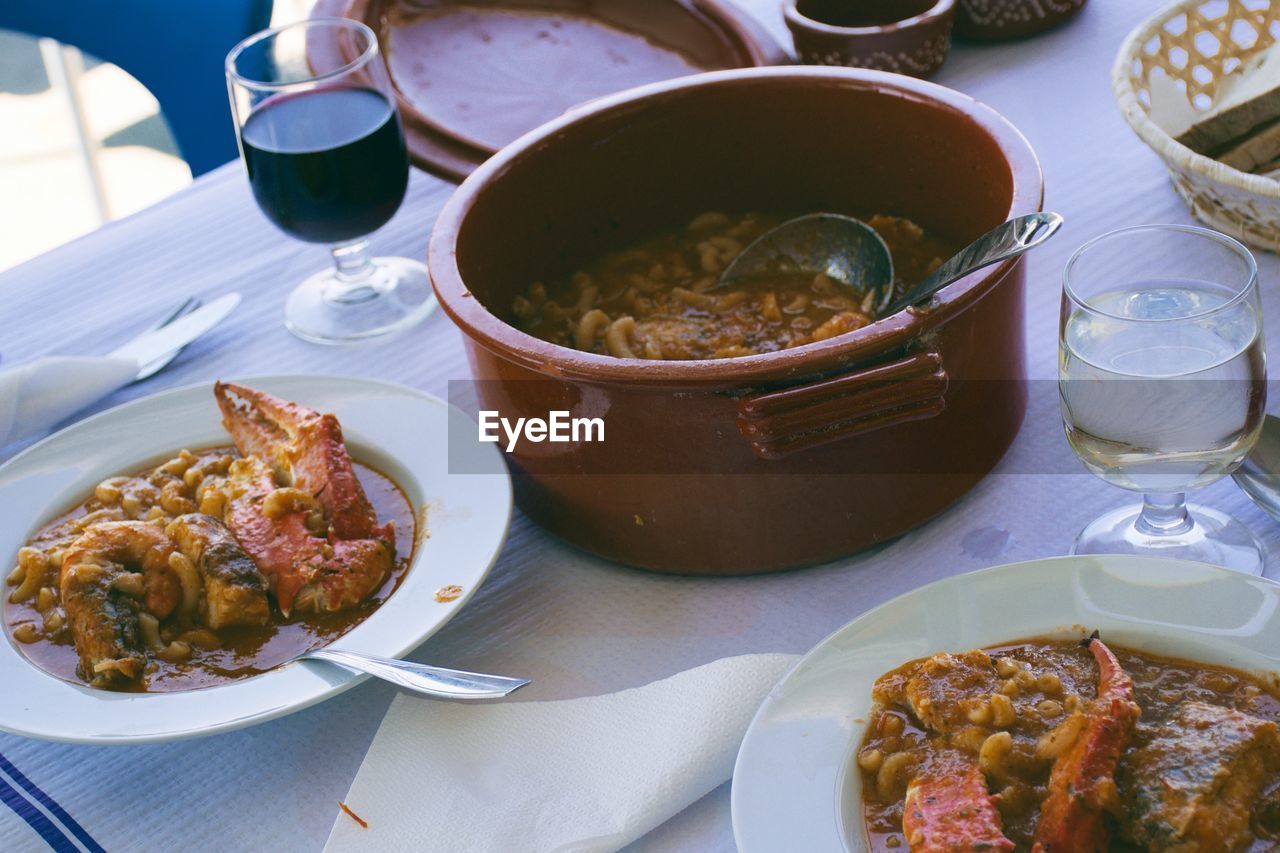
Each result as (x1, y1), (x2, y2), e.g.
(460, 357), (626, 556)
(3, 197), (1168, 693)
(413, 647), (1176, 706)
(0, 0), (1280, 852)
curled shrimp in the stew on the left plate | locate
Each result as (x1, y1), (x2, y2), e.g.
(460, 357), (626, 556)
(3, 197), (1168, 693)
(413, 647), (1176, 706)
(59, 521), (180, 686)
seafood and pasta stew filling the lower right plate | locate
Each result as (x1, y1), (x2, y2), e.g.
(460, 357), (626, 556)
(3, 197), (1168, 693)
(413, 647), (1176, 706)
(855, 633), (1280, 853)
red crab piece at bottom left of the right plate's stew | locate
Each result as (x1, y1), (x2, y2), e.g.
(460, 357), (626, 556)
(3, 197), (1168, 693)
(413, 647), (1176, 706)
(902, 753), (1014, 853)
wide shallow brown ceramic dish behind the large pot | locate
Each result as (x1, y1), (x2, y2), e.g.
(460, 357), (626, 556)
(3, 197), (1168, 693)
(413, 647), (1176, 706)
(317, 0), (787, 179)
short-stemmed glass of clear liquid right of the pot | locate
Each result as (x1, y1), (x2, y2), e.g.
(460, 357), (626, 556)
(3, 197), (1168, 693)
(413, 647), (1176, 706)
(1059, 225), (1266, 574)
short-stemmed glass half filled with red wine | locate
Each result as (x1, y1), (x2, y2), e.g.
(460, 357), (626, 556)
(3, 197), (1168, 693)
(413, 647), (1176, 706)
(227, 18), (435, 343)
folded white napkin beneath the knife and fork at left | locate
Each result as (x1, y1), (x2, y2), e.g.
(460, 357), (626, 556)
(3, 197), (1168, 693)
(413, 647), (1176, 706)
(0, 356), (138, 447)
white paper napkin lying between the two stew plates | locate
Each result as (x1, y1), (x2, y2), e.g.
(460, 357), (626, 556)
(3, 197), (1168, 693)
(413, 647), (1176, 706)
(325, 654), (799, 853)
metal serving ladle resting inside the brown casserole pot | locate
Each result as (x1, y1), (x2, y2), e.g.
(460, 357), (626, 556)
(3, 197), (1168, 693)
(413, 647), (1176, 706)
(719, 213), (1062, 316)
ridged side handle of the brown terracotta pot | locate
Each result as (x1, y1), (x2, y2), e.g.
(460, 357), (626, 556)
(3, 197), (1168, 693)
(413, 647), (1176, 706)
(737, 348), (948, 459)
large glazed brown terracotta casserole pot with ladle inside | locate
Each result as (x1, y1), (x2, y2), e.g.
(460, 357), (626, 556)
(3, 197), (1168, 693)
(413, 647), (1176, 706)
(430, 68), (1042, 575)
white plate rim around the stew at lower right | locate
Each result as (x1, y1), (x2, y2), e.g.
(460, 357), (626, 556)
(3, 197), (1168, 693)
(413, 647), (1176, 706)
(732, 557), (1280, 853)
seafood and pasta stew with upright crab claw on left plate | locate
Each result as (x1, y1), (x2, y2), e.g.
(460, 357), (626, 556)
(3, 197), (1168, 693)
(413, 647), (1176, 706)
(4, 383), (416, 692)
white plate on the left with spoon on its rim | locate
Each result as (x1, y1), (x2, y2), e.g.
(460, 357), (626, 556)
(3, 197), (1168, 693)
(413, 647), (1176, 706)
(0, 375), (511, 743)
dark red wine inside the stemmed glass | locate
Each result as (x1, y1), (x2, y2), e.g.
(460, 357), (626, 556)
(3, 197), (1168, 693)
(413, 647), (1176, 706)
(241, 88), (408, 243)
